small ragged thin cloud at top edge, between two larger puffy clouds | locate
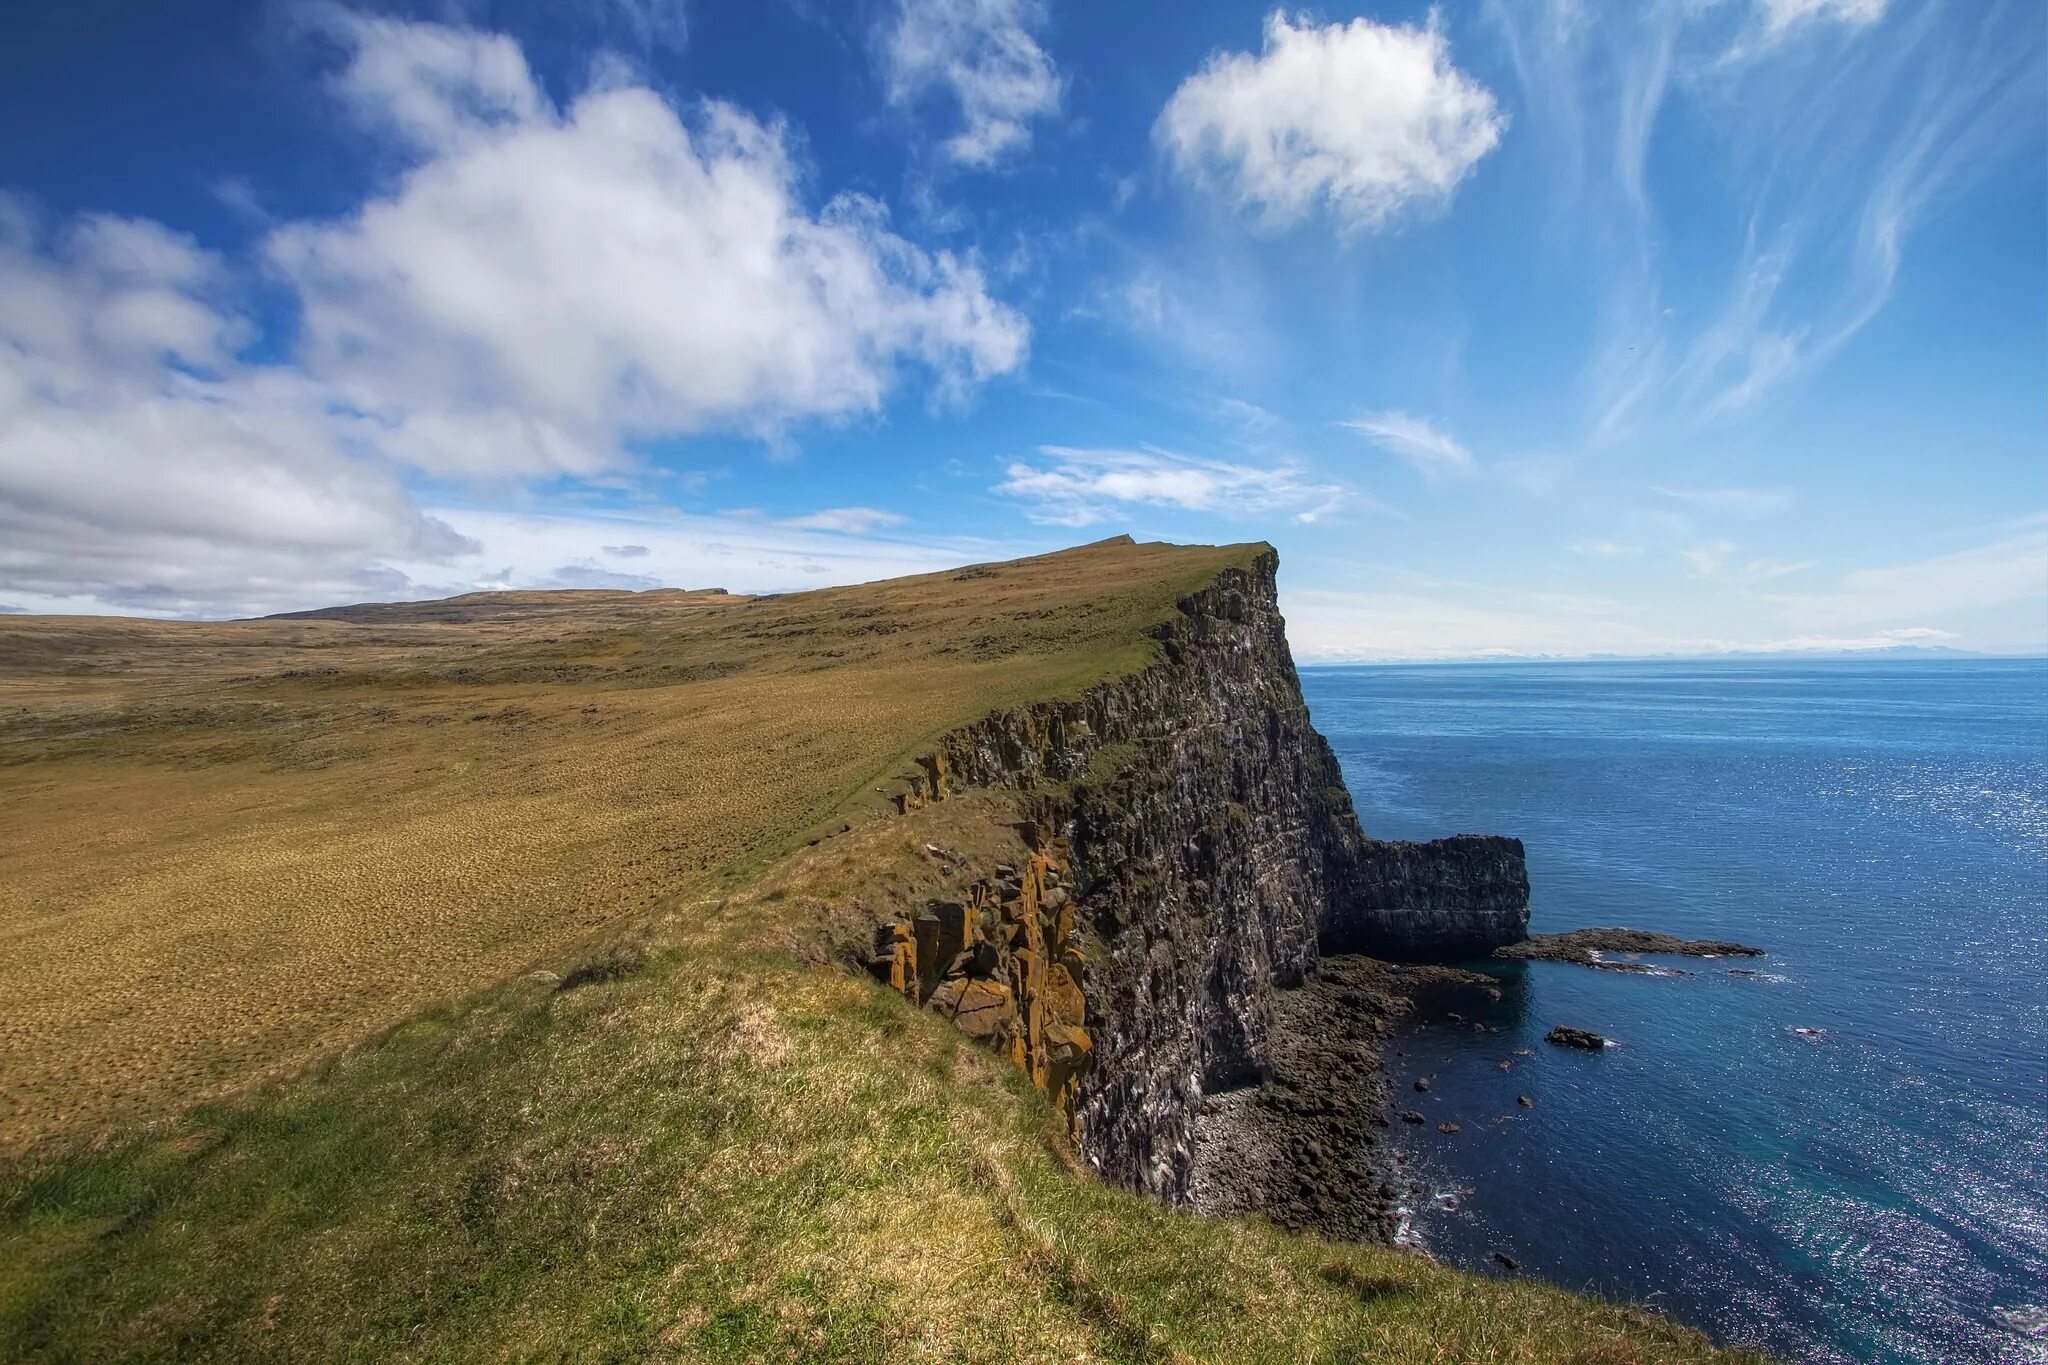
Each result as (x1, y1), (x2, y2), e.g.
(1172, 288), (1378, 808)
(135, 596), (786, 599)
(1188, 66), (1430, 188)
(877, 0), (1061, 170)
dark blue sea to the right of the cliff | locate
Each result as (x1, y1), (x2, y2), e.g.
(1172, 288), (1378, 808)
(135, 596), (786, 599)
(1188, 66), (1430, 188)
(1303, 661), (2048, 1363)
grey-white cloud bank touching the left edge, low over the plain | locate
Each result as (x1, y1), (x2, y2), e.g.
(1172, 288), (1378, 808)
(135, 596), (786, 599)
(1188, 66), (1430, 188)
(0, 205), (473, 612)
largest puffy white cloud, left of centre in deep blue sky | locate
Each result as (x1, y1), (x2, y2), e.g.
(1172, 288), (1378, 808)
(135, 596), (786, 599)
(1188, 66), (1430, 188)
(268, 18), (1026, 475)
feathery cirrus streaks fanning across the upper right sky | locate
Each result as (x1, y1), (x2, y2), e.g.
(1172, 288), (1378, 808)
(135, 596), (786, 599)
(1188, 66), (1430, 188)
(1487, 0), (2048, 440)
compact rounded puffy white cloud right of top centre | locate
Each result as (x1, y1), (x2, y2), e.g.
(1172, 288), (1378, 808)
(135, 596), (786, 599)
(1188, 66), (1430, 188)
(1155, 10), (1505, 231)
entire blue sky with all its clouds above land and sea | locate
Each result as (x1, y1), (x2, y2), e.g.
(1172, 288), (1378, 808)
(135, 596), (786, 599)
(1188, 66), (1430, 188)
(0, 0), (2048, 661)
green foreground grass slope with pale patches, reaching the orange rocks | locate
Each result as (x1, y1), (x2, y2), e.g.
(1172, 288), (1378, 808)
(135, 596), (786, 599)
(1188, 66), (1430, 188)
(0, 544), (1761, 1363)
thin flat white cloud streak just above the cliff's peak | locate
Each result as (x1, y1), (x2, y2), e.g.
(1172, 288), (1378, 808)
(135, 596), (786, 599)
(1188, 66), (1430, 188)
(995, 446), (1343, 526)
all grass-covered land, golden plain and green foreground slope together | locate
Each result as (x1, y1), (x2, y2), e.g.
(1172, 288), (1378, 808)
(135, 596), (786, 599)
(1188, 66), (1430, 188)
(0, 544), (1761, 1363)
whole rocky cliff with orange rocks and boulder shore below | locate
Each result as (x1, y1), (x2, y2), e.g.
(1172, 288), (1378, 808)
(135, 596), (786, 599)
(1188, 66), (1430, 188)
(868, 546), (1528, 1238)
